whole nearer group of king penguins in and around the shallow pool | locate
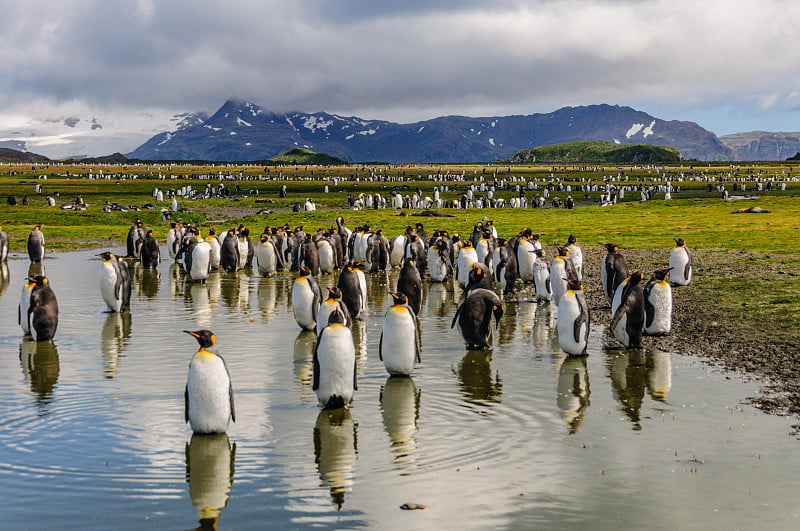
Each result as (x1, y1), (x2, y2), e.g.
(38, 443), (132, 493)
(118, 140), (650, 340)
(0, 217), (692, 433)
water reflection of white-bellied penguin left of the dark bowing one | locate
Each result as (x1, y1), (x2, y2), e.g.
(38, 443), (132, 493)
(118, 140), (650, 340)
(380, 376), (420, 470)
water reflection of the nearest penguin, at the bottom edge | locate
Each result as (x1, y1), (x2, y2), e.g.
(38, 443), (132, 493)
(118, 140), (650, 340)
(186, 433), (236, 529)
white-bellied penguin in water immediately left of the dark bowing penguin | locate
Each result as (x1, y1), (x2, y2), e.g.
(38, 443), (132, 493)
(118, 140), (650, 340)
(378, 294), (421, 376)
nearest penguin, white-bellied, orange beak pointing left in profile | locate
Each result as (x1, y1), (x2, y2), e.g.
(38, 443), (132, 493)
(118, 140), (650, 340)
(183, 330), (236, 433)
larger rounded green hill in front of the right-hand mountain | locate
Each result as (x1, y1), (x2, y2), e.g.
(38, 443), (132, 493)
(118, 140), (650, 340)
(501, 140), (681, 164)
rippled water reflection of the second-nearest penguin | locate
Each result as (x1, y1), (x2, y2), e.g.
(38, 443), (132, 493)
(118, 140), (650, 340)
(314, 408), (357, 510)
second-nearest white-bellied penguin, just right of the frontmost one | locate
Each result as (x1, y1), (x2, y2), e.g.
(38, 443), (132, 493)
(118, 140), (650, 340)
(311, 310), (358, 409)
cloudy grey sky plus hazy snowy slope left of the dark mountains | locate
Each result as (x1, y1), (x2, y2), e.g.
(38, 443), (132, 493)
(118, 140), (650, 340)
(0, 0), (800, 156)
